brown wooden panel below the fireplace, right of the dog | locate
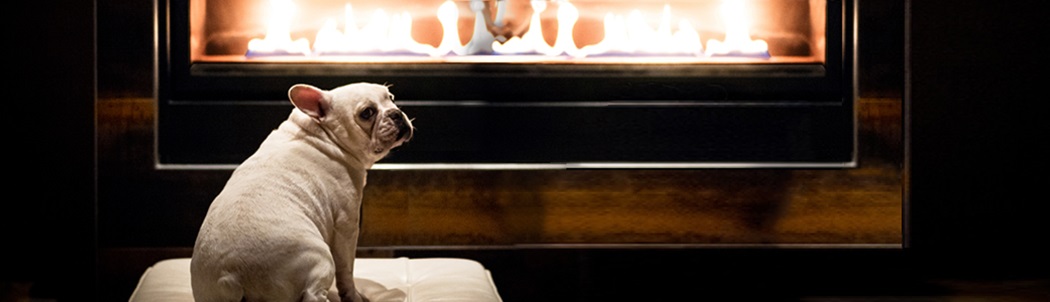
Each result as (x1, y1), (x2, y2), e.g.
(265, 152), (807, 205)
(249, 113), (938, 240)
(362, 161), (902, 245)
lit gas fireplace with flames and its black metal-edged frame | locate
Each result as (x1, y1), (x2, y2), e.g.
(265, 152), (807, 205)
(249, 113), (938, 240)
(156, 0), (857, 169)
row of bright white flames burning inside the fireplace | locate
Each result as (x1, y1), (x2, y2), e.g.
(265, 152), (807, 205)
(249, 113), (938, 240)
(248, 0), (769, 58)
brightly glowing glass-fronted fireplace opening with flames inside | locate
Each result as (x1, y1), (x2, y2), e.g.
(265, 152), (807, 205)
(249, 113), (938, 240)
(190, 0), (826, 64)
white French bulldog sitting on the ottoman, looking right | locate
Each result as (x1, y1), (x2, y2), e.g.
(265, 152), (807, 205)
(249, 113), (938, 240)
(190, 83), (415, 302)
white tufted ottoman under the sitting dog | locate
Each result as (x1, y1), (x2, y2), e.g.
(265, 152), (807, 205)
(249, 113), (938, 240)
(129, 258), (502, 302)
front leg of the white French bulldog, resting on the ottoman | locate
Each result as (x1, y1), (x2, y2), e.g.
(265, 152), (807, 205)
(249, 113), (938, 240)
(332, 219), (368, 302)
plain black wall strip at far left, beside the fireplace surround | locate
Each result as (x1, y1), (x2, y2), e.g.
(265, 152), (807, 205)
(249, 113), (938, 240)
(6, 0), (96, 301)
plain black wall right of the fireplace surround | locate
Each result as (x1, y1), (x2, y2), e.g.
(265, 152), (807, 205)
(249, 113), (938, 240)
(905, 1), (1050, 275)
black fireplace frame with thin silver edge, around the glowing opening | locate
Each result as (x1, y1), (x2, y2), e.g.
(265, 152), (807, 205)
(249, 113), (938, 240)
(155, 0), (858, 169)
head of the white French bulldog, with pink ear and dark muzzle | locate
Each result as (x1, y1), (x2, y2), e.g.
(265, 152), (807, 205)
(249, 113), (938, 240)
(288, 83), (415, 163)
